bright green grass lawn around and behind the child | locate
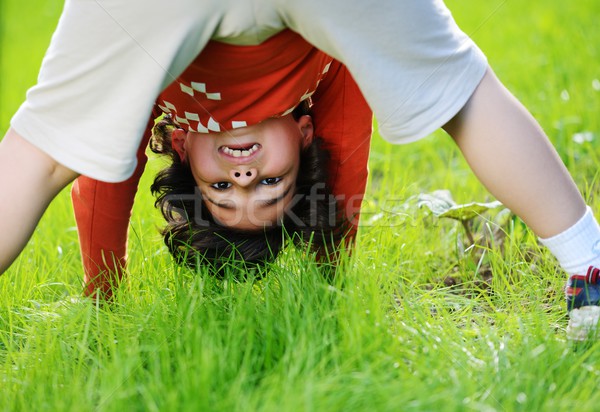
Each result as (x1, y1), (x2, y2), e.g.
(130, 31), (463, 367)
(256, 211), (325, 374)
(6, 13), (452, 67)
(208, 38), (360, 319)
(0, 0), (600, 412)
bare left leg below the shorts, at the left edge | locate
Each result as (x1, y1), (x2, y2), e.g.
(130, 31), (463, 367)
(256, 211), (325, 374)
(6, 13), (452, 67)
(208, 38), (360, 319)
(0, 129), (77, 273)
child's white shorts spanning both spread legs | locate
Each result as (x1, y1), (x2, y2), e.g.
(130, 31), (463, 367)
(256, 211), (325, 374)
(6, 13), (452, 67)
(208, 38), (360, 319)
(11, 0), (487, 182)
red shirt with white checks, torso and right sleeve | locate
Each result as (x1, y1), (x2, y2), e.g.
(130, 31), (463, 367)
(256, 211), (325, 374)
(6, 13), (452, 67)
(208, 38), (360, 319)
(152, 30), (372, 236)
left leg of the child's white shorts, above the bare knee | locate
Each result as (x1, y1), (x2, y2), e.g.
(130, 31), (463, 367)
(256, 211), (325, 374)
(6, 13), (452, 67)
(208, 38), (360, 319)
(11, 0), (219, 182)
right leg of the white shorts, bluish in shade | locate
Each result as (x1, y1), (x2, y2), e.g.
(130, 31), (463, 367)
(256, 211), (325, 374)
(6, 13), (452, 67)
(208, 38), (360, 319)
(279, 0), (487, 143)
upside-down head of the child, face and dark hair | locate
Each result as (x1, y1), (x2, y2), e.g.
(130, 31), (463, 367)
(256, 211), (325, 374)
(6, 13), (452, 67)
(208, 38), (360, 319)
(151, 103), (340, 274)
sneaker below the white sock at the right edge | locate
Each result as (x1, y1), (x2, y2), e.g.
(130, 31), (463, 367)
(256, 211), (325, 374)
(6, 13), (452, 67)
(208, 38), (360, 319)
(565, 266), (600, 341)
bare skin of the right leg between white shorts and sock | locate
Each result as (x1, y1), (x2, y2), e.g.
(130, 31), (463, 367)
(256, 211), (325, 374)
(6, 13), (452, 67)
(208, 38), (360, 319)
(444, 69), (585, 237)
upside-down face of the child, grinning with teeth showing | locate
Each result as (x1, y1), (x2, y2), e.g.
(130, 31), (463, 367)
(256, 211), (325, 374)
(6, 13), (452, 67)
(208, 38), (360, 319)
(172, 114), (313, 230)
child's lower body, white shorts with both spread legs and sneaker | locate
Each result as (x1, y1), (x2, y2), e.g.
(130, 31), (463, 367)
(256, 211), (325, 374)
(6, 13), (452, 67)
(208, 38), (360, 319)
(0, 0), (600, 338)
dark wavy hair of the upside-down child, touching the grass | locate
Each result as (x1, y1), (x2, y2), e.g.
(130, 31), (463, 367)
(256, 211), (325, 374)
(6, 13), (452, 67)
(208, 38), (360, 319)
(150, 102), (341, 275)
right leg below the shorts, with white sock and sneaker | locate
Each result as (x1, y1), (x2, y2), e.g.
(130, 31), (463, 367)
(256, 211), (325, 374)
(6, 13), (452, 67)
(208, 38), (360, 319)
(444, 66), (600, 340)
